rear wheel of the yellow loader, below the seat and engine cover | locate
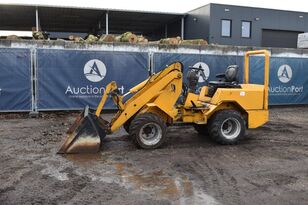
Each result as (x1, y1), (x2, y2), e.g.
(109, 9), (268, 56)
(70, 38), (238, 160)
(209, 110), (246, 145)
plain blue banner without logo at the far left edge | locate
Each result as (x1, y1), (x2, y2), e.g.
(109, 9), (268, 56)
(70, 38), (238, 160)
(0, 48), (32, 112)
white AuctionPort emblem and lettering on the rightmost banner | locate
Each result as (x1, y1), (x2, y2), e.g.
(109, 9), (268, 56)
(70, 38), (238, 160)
(269, 64), (304, 95)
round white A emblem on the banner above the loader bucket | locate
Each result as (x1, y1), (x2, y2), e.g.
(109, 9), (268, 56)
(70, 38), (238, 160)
(83, 59), (107, 83)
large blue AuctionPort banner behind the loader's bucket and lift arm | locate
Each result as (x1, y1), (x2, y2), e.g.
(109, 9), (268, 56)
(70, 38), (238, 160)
(37, 49), (148, 110)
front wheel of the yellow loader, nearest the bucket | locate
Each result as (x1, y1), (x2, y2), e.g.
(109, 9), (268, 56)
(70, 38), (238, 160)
(129, 113), (167, 149)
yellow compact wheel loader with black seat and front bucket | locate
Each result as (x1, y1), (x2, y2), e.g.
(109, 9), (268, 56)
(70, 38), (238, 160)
(58, 50), (269, 153)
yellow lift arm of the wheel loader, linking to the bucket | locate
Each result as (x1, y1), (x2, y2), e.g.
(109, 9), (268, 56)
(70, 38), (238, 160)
(96, 62), (183, 133)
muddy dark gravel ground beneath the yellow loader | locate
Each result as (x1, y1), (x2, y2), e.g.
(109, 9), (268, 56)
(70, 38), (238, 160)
(0, 107), (308, 205)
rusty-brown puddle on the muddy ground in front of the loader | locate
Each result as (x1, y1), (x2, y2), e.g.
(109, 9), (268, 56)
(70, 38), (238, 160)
(111, 162), (220, 205)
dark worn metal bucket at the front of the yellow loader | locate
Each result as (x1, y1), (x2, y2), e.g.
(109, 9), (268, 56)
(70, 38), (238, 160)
(58, 107), (108, 154)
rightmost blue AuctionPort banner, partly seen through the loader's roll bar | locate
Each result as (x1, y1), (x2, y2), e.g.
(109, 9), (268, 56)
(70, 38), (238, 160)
(250, 57), (308, 105)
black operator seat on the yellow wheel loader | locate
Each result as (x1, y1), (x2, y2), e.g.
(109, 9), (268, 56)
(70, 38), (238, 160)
(208, 65), (241, 97)
